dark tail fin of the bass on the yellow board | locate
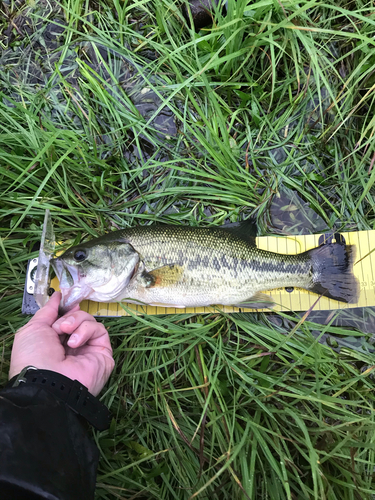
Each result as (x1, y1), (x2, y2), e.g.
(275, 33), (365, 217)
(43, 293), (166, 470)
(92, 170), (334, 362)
(307, 243), (359, 304)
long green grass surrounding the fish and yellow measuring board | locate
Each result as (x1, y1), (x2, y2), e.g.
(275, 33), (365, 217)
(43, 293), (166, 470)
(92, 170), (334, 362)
(0, 0), (375, 500)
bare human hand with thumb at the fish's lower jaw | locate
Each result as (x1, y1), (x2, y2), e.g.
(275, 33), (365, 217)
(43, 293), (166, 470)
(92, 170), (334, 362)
(9, 292), (115, 396)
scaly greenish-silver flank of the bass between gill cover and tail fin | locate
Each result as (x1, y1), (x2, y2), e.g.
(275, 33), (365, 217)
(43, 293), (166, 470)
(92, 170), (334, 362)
(103, 226), (318, 307)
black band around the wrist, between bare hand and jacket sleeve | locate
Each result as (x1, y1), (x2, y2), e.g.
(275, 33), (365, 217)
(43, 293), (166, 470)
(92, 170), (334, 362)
(6, 366), (111, 431)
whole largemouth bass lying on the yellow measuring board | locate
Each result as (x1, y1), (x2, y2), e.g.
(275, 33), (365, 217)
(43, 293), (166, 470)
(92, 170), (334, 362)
(52, 222), (358, 313)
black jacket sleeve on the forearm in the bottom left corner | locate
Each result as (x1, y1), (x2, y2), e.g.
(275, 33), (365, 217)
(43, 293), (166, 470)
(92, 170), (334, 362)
(0, 384), (99, 500)
